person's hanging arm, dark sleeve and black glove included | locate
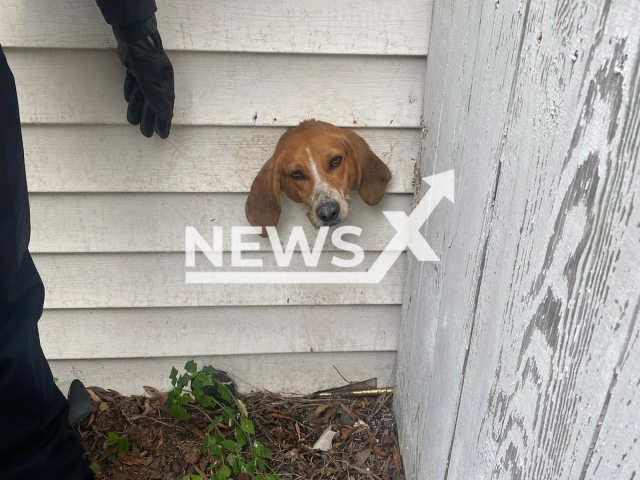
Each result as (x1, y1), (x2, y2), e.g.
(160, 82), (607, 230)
(96, 0), (175, 138)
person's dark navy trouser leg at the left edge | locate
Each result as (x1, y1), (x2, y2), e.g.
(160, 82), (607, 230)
(0, 49), (93, 480)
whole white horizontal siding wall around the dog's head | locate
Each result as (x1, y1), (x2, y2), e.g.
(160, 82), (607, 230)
(0, 0), (432, 393)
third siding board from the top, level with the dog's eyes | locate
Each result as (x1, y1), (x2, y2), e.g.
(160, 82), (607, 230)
(22, 125), (420, 193)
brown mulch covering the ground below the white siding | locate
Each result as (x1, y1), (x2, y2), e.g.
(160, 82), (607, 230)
(81, 387), (405, 480)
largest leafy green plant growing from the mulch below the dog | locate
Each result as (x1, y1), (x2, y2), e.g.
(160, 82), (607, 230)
(166, 360), (278, 480)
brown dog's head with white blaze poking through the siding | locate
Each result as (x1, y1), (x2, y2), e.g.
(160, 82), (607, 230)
(245, 120), (391, 236)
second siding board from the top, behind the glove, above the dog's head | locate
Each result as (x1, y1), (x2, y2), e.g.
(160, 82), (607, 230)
(5, 49), (426, 127)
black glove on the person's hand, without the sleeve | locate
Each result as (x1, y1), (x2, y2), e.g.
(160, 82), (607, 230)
(113, 15), (175, 138)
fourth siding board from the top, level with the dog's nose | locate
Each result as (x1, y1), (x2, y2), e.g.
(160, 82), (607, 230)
(30, 192), (413, 253)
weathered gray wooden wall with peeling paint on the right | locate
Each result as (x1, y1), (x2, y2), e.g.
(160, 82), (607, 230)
(396, 0), (640, 480)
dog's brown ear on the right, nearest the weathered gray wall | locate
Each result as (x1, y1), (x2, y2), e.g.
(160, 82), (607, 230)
(344, 130), (391, 205)
